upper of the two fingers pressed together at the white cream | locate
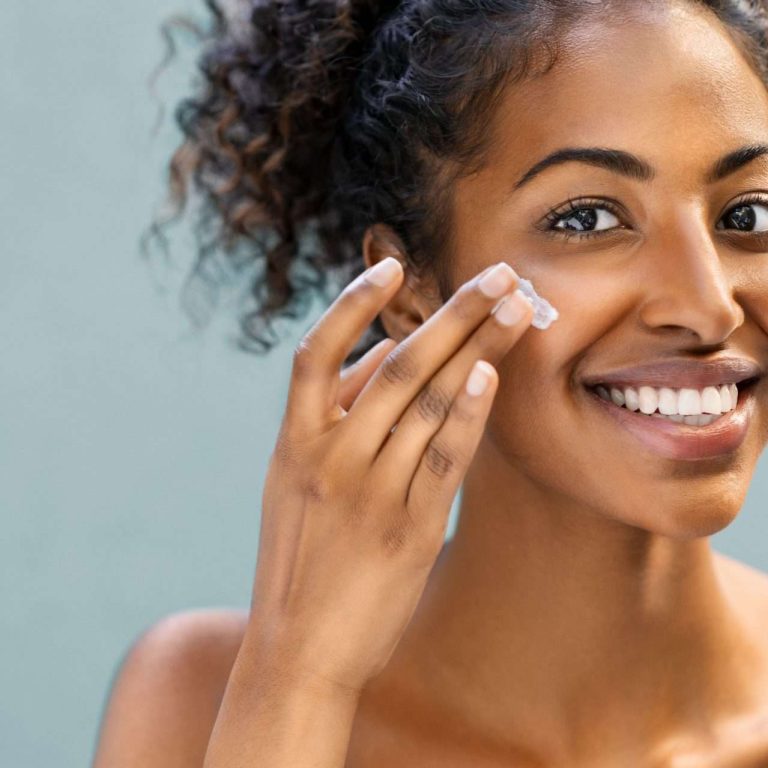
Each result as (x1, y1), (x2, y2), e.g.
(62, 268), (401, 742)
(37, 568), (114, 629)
(345, 263), (518, 460)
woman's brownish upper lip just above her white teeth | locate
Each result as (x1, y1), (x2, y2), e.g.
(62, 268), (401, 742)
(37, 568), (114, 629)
(583, 357), (763, 389)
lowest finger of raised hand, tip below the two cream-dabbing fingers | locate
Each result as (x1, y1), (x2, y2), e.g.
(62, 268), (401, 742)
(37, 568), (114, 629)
(408, 360), (499, 530)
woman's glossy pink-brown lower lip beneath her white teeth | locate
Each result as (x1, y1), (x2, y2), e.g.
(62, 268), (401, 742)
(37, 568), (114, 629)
(587, 384), (756, 459)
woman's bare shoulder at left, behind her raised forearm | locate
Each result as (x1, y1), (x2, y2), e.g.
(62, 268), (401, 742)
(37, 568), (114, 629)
(94, 608), (248, 768)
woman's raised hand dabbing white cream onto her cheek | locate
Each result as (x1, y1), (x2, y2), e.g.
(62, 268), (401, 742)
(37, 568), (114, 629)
(247, 258), (533, 692)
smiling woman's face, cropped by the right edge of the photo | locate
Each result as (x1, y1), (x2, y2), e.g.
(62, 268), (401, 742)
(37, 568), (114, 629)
(453, 5), (768, 538)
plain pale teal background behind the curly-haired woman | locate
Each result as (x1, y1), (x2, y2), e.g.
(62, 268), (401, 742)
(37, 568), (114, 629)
(0, 0), (768, 768)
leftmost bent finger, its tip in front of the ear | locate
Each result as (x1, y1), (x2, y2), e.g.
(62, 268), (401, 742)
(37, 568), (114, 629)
(285, 256), (403, 434)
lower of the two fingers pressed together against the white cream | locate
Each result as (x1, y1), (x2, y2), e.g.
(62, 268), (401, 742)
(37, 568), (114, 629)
(375, 291), (533, 477)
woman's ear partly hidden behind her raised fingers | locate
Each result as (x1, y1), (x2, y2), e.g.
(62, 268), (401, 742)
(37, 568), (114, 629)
(363, 222), (440, 343)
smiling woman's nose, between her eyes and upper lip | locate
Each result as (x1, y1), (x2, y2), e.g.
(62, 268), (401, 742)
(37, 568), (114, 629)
(640, 212), (744, 344)
